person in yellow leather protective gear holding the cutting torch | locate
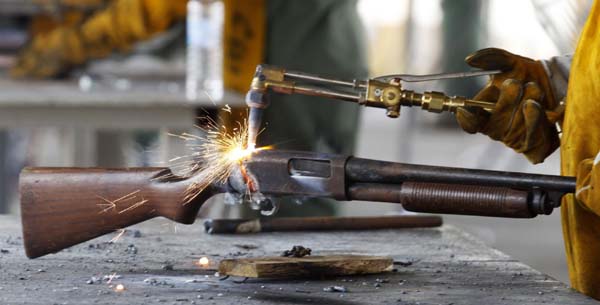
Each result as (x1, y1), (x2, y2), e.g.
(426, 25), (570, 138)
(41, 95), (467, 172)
(456, 1), (600, 300)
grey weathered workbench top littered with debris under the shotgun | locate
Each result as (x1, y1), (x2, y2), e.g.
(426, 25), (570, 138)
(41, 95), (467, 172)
(0, 216), (597, 305)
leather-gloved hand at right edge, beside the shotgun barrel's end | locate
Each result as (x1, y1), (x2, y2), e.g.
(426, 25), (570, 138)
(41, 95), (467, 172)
(575, 153), (600, 211)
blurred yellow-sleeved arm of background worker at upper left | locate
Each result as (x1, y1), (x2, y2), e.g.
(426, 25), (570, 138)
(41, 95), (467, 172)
(11, 0), (187, 78)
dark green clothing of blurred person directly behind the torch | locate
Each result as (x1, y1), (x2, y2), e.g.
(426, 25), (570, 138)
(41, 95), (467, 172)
(259, 0), (367, 154)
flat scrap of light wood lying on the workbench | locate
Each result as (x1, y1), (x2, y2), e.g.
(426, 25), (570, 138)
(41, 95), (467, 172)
(219, 255), (393, 278)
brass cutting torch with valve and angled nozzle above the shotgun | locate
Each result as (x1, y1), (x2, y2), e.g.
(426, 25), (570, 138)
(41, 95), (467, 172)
(246, 65), (502, 146)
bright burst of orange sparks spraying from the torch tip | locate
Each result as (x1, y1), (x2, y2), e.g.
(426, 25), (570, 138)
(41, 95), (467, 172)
(162, 110), (270, 204)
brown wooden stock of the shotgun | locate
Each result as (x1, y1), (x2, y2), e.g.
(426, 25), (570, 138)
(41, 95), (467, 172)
(19, 168), (213, 258)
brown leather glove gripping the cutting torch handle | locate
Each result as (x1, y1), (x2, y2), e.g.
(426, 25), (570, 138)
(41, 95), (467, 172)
(456, 48), (560, 163)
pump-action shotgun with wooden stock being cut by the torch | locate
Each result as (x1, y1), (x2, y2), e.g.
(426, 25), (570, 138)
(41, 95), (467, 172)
(19, 150), (575, 258)
